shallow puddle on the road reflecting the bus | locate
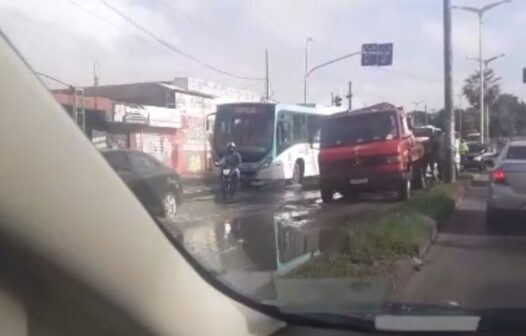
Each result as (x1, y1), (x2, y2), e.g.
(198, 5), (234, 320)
(179, 209), (319, 273)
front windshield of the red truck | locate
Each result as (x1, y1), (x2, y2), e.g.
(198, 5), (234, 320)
(321, 112), (398, 148)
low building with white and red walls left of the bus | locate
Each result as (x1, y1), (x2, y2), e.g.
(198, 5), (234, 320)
(54, 78), (261, 175)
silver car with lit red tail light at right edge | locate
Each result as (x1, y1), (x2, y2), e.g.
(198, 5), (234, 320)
(486, 140), (526, 225)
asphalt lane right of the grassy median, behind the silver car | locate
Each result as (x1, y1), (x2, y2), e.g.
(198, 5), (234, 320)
(398, 182), (526, 308)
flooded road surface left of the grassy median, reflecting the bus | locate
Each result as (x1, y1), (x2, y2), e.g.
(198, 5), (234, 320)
(169, 184), (395, 298)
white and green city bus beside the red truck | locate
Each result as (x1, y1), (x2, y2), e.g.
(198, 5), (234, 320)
(213, 103), (333, 184)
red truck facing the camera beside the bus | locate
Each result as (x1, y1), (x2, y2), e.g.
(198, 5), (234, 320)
(318, 103), (426, 202)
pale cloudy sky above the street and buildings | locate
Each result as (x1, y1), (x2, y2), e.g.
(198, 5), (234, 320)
(0, 0), (526, 109)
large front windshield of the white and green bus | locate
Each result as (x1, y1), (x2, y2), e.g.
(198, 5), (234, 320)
(214, 105), (274, 161)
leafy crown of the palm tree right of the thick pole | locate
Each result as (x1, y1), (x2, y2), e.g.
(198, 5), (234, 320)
(462, 69), (501, 108)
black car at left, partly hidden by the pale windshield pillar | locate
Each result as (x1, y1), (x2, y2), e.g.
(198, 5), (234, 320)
(102, 150), (183, 219)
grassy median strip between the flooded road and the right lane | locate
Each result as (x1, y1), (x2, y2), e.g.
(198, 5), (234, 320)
(288, 183), (463, 278)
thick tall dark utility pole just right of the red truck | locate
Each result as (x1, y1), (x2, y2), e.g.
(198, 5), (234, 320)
(443, 0), (457, 183)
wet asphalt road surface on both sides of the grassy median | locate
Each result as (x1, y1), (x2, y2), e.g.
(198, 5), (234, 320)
(170, 177), (526, 308)
